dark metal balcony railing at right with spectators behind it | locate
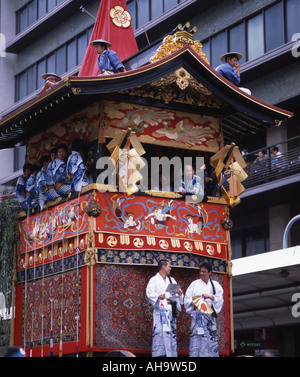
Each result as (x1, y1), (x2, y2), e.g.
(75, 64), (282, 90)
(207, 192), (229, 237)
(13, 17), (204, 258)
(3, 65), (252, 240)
(243, 136), (300, 188)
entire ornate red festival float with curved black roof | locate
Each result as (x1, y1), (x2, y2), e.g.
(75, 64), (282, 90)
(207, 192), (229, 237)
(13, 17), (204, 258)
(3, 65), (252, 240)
(0, 5), (292, 357)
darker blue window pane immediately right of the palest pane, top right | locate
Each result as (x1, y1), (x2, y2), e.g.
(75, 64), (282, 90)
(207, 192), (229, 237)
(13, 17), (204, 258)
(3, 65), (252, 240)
(265, 2), (284, 52)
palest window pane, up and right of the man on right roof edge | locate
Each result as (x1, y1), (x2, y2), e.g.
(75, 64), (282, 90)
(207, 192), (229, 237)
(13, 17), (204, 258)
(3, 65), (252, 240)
(247, 14), (265, 60)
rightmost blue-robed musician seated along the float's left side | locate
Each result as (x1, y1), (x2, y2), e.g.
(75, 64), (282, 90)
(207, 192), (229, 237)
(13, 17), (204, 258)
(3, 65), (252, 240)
(65, 139), (92, 193)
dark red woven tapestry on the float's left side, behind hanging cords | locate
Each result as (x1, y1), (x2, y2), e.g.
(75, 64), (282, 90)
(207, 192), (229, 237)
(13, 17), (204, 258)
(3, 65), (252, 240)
(22, 270), (81, 348)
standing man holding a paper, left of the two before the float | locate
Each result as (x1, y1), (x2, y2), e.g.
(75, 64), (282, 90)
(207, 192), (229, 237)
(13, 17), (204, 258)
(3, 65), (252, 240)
(146, 259), (184, 357)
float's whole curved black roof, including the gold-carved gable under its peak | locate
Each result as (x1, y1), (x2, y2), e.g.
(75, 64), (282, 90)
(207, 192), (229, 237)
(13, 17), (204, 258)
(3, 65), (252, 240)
(0, 44), (293, 149)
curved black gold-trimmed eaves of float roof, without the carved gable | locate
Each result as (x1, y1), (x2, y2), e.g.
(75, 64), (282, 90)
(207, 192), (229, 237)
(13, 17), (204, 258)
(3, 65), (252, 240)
(0, 45), (293, 148)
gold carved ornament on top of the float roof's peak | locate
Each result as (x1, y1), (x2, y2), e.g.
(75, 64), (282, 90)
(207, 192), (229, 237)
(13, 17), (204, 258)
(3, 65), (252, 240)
(150, 22), (209, 64)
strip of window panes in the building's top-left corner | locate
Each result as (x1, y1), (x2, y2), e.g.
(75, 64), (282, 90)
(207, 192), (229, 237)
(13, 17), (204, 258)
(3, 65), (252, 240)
(16, 0), (65, 34)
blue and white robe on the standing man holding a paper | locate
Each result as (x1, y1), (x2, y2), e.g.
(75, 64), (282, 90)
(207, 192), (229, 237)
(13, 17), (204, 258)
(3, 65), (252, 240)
(146, 273), (183, 357)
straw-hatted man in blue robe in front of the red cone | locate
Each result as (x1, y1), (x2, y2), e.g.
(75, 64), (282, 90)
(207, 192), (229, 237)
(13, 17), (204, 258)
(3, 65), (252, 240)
(90, 39), (126, 75)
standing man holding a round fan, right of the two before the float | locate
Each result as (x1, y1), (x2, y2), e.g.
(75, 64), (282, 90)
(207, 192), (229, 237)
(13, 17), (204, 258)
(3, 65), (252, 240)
(184, 263), (224, 357)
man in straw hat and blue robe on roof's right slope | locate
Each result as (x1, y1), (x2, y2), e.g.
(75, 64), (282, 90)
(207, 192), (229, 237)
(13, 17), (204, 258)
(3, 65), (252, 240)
(216, 52), (251, 95)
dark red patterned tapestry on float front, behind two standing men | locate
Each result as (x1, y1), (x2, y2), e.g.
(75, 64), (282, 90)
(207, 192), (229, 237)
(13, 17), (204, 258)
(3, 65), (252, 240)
(95, 265), (229, 353)
